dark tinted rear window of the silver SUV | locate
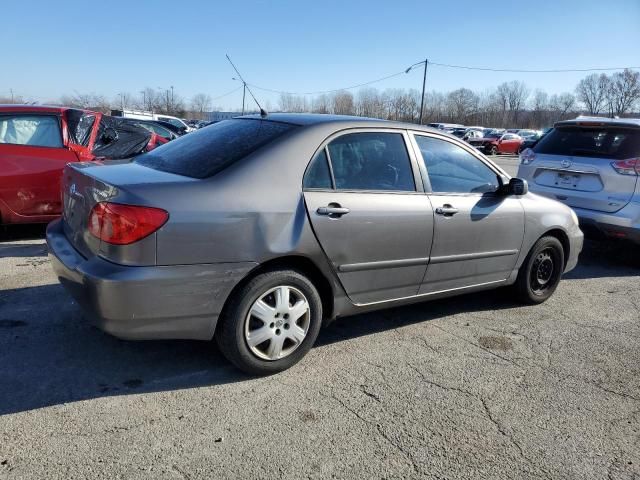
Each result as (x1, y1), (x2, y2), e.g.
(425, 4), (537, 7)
(533, 127), (640, 160)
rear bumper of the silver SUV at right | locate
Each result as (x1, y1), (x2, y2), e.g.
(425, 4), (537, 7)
(574, 199), (640, 244)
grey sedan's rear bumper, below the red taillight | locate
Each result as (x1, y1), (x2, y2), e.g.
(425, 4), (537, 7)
(47, 220), (257, 340)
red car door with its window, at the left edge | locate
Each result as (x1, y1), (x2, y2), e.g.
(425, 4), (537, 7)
(0, 113), (77, 221)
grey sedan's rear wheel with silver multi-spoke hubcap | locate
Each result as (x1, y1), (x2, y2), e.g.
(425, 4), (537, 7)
(215, 270), (322, 375)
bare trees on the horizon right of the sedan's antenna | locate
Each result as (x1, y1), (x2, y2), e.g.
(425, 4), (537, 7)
(278, 70), (640, 128)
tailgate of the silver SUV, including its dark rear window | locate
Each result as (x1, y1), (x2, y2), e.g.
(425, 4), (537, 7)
(527, 124), (640, 213)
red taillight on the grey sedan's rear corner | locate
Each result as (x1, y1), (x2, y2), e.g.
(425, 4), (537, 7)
(89, 202), (169, 245)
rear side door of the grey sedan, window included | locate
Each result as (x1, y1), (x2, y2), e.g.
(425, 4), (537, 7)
(304, 129), (433, 304)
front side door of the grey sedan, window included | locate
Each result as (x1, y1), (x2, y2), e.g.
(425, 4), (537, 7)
(415, 134), (524, 294)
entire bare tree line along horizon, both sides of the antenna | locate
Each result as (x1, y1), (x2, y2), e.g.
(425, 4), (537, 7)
(0, 69), (640, 128)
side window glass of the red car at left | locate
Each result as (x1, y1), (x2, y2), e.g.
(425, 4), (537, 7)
(0, 115), (62, 148)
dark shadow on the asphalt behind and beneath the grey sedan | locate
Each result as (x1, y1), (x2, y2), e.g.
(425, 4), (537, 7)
(0, 285), (514, 416)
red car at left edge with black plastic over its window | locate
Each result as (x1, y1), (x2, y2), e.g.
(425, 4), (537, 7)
(0, 105), (166, 224)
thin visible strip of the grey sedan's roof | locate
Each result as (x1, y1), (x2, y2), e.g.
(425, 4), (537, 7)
(235, 113), (444, 138)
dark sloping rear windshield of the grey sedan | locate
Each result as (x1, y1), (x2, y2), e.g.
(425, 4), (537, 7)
(135, 119), (296, 178)
